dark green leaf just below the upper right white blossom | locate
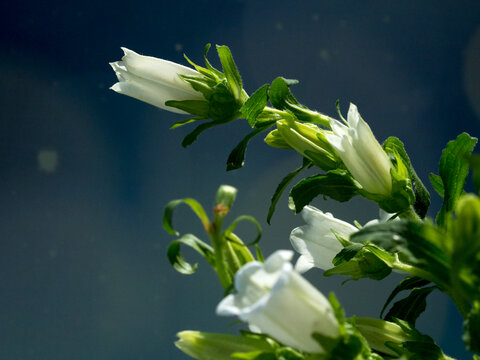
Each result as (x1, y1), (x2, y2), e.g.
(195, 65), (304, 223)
(290, 170), (358, 214)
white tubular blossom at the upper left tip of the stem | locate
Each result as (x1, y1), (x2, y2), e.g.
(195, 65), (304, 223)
(110, 47), (203, 114)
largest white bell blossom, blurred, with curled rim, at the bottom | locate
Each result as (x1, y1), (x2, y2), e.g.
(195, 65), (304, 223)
(217, 250), (339, 353)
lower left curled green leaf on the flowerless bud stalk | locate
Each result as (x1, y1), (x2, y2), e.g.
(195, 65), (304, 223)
(167, 234), (215, 275)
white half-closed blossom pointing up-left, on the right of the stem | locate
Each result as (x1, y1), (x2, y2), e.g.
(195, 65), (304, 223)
(325, 104), (393, 196)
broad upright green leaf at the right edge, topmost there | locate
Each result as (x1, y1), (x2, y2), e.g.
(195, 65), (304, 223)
(436, 133), (477, 226)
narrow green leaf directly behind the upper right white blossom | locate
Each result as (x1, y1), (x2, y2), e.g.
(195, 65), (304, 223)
(383, 136), (430, 219)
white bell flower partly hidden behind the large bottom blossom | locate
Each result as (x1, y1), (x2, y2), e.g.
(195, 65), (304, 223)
(290, 206), (358, 273)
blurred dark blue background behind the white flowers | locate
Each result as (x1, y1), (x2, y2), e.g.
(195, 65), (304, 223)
(0, 0), (480, 360)
